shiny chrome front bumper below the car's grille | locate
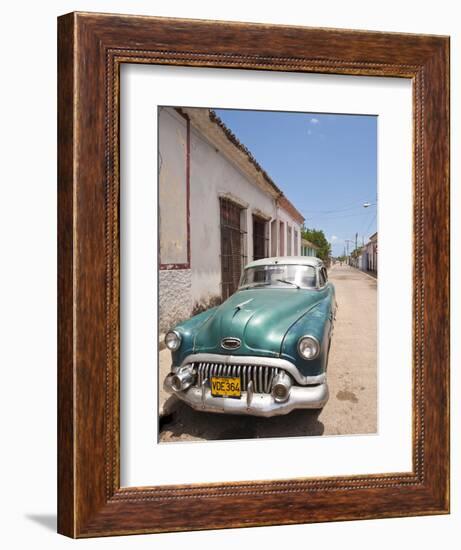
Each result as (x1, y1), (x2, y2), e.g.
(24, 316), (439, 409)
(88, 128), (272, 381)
(163, 373), (328, 417)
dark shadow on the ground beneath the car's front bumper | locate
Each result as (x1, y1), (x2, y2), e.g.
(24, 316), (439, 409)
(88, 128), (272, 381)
(159, 396), (324, 442)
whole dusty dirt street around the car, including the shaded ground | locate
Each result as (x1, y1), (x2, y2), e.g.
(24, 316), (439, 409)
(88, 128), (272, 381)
(160, 265), (377, 442)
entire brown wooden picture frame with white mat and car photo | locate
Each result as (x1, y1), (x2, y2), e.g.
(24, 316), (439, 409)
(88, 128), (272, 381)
(58, 13), (449, 537)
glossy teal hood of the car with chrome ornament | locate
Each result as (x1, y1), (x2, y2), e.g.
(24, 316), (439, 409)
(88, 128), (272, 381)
(194, 287), (323, 356)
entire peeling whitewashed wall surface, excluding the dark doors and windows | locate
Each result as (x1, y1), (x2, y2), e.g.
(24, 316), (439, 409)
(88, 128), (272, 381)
(159, 107), (306, 332)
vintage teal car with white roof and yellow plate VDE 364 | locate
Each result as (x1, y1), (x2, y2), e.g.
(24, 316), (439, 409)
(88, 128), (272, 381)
(164, 256), (336, 416)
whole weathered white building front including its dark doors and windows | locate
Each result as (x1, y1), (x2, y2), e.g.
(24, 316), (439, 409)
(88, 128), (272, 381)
(158, 107), (304, 332)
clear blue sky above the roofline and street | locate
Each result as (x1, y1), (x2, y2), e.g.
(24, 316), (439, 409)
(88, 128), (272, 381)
(216, 109), (377, 256)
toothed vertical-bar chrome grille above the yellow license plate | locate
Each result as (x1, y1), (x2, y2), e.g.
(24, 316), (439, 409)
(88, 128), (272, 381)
(191, 363), (282, 393)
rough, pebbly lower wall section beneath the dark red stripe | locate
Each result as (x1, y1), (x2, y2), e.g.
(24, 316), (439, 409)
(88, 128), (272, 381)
(158, 269), (192, 334)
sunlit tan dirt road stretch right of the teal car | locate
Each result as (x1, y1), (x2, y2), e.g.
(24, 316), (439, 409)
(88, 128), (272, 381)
(319, 265), (378, 434)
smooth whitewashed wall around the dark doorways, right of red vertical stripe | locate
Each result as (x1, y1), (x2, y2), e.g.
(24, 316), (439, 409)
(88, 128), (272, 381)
(190, 127), (276, 304)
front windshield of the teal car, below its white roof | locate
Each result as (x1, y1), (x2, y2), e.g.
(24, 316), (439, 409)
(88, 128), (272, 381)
(240, 264), (316, 288)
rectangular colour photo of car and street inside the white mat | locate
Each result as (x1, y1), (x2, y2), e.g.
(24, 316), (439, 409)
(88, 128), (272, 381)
(154, 105), (379, 443)
